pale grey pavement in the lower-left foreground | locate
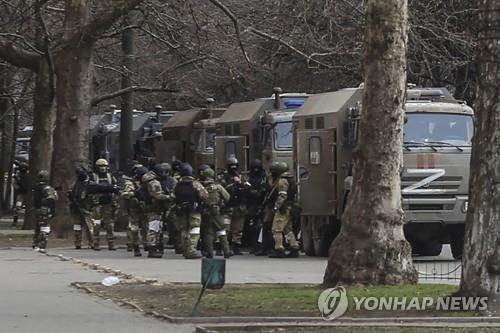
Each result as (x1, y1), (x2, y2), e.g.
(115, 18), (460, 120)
(0, 249), (194, 333)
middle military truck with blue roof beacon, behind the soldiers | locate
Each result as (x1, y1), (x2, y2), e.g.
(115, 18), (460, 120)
(215, 88), (308, 173)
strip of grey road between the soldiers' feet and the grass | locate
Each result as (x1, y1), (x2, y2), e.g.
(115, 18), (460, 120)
(51, 246), (460, 284)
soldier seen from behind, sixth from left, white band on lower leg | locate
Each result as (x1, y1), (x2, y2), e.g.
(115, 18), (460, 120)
(175, 163), (208, 259)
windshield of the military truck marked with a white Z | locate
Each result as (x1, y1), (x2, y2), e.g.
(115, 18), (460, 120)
(404, 113), (474, 146)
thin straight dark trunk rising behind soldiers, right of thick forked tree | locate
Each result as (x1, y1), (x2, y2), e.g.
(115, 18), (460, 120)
(119, 11), (136, 172)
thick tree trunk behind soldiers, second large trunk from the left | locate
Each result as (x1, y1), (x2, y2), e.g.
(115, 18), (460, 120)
(51, 43), (93, 237)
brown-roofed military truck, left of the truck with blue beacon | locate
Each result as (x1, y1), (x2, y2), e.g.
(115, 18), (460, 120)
(155, 101), (226, 169)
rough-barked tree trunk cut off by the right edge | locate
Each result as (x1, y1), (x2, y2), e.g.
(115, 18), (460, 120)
(460, 0), (500, 313)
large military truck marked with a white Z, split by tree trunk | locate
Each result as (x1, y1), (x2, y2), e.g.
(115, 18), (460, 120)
(294, 88), (473, 258)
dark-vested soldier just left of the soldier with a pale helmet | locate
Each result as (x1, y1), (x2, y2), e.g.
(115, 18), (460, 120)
(68, 166), (94, 250)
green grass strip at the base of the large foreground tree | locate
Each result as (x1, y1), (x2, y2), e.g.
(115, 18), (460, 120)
(76, 283), (476, 318)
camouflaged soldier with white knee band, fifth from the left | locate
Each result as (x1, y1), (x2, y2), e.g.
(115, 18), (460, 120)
(141, 171), (173, 257)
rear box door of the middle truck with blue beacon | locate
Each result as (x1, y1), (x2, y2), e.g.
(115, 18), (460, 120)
(215, 136), (249, 172)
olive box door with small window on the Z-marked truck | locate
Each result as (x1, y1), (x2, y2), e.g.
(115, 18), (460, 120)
(297, 130), (337, 216)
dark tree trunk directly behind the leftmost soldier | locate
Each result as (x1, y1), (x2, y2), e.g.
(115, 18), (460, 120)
(23, 59), (56, 230)
